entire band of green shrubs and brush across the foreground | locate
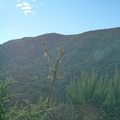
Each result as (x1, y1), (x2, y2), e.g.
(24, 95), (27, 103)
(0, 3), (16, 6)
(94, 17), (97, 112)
(0, 69), (120, 120)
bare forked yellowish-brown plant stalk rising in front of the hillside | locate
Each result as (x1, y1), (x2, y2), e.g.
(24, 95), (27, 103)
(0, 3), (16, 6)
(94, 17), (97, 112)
(31, 42), (65, 105)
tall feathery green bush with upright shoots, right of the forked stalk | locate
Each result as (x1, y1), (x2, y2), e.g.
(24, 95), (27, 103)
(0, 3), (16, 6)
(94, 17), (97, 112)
(67, 68), (120, 120)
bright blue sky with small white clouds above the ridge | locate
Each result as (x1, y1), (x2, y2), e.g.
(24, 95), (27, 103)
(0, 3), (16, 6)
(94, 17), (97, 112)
(0, 0), (120, 44)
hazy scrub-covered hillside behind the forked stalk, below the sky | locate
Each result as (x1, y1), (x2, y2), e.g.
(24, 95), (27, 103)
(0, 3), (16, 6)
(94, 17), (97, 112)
(0, 28), (120, 102)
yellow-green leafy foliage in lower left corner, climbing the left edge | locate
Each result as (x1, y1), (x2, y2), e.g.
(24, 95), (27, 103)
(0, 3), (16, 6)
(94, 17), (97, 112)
(0, 78), (53, 120)
